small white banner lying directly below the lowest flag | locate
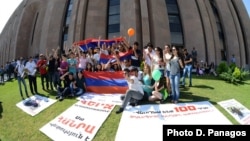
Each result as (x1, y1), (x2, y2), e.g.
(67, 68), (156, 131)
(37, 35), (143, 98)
(77, 92), (124, 105)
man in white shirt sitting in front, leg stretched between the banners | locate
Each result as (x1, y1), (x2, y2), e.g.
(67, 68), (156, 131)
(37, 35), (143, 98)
(116, 68), (144, 114)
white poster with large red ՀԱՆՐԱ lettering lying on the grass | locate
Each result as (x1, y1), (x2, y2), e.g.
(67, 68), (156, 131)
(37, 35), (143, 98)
(40, 100), (115, 141)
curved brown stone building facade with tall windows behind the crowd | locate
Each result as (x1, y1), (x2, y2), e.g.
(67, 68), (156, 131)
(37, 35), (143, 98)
(0, 0), (250, 67)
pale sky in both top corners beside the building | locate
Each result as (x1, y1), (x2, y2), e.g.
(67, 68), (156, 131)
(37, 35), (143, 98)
(0, 0), (250, 33)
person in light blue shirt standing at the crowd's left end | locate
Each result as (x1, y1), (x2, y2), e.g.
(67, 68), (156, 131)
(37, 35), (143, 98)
(14, 57), (29, 100)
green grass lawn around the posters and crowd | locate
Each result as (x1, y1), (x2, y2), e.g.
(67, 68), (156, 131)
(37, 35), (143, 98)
(0, 76), (250, 141)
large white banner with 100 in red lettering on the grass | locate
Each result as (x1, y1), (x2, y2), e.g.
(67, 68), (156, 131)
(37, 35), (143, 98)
(115, 101), (232, 141)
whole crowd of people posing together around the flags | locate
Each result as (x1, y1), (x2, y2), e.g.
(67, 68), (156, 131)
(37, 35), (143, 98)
(2, 38), (199, 113)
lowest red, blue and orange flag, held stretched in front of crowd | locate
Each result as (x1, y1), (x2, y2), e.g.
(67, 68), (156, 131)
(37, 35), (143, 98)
(83, 71), (128, 94)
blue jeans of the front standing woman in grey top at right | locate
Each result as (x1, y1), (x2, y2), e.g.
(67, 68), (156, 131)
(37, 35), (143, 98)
(170, 73), (180, 101)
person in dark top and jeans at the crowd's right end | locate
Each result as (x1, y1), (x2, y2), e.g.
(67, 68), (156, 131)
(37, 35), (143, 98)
(182, 48), (193, 87)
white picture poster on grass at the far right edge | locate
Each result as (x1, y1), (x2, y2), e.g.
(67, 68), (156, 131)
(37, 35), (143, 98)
(218, 99), (250, 124)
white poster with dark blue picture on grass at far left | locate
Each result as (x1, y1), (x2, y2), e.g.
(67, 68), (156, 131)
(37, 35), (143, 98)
(16, 95), (57, 116)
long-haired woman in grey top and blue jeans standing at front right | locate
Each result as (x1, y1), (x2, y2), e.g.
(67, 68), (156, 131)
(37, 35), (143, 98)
(169, 46), (183, 103)
